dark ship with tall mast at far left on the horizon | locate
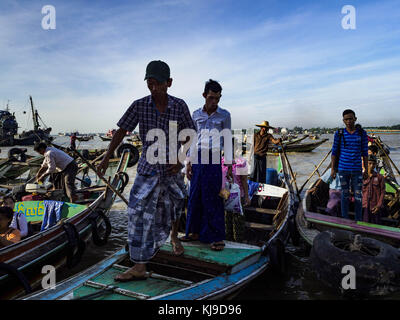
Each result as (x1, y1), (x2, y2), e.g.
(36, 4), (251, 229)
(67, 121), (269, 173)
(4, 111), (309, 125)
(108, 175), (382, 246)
(0, 96), (53, 146)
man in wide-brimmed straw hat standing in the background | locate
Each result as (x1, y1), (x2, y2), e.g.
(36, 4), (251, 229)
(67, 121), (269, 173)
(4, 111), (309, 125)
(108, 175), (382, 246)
(250, 121), (282, 183)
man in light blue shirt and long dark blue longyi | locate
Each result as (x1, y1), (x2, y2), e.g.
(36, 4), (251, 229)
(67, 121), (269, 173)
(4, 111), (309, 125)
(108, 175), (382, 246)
(181, 79), (233, 251)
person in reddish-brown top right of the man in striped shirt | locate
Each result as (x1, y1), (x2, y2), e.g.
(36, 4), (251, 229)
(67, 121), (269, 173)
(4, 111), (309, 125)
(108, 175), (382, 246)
(362, 155), (385, 224)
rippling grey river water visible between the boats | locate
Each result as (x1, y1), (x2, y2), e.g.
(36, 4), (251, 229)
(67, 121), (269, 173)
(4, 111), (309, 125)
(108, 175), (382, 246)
(0, 134), (400, 300)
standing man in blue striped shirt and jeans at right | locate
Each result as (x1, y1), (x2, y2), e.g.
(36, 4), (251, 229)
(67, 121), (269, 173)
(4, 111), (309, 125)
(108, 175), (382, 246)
(331, 109), (368, 221)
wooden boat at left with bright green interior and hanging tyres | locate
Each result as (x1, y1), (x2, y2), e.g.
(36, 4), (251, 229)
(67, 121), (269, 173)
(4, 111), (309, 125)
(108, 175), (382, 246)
(0, 150), (134, 299)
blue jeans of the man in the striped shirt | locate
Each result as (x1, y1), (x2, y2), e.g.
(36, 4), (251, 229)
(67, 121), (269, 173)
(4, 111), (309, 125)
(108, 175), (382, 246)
(338, 170), (363, 221)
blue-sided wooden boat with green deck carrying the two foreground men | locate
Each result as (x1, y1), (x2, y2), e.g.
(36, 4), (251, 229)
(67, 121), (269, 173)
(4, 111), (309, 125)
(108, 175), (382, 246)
(24, 152), (295, 300)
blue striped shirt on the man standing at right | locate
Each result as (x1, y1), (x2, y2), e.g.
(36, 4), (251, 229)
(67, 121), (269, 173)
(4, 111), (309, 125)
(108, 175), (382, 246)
(332, 129), (368, 171)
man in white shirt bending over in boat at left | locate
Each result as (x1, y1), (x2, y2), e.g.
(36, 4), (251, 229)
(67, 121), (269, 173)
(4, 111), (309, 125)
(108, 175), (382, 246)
(34, 142), (78, 203)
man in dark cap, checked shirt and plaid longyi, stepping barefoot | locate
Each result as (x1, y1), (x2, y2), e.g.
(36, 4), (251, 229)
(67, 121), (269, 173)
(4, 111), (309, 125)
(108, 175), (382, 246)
(98, 60), (195, 281)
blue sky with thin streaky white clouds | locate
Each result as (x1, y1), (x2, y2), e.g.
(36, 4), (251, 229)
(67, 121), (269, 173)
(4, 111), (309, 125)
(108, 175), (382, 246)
(0, 0), (400, 133)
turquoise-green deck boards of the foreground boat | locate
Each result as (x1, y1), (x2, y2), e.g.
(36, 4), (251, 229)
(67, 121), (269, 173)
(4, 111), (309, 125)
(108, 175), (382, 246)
(73, 241), (261, 300)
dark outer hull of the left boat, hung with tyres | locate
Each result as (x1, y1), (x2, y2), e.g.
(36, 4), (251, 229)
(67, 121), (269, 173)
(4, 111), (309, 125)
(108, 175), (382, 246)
(0, 149), (129, 299)
